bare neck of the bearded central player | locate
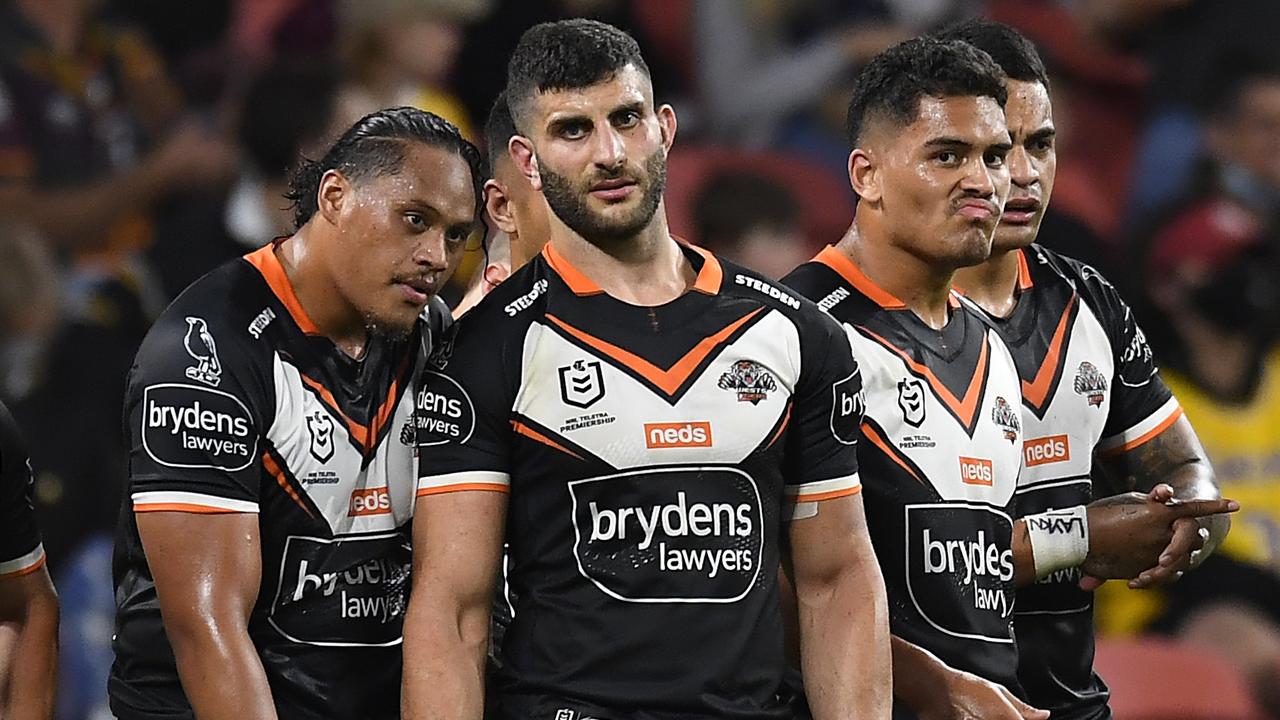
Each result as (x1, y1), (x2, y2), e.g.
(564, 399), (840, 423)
(550, 206), (698, 307)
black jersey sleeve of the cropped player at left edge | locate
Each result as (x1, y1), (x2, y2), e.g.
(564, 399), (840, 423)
(0, 405), (45, 579)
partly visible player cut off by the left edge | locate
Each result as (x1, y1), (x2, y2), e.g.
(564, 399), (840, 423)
(0, 402), (58, 720)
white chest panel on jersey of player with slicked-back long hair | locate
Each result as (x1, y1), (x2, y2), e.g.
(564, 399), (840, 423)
(266, 354), (417, 536)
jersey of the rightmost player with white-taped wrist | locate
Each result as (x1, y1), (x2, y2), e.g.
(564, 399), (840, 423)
(977, 245), (1181, 720)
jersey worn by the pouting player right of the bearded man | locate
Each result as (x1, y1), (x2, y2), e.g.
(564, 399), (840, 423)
(782, 247), (1023, 687)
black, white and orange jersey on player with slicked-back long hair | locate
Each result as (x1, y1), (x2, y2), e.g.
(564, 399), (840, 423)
(109, 243), (430, 720)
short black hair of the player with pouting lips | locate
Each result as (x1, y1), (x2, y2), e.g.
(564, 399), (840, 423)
(845, 37), (1009, 147)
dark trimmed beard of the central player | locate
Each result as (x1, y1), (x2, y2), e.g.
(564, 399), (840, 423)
(541, 149), (667, 245)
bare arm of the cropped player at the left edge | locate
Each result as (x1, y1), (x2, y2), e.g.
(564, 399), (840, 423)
(4, 570), (58, 720)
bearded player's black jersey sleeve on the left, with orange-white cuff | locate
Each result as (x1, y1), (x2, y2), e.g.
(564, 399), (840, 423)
(413, 314), (520, 497)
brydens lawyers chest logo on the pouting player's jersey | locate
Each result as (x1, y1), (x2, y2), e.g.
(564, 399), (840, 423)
(906, 502), (1014, 643)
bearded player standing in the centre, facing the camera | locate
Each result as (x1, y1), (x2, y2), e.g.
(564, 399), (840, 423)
(404, 20), (890, 720)
